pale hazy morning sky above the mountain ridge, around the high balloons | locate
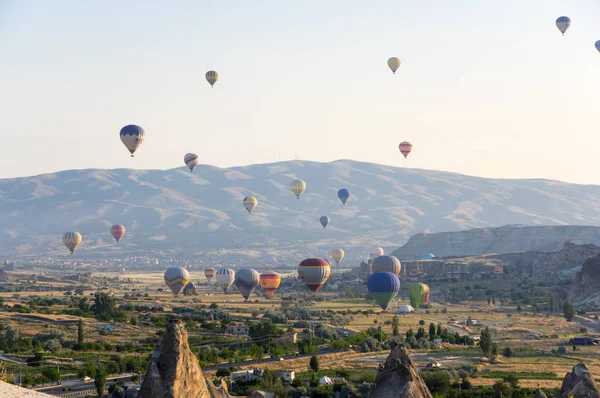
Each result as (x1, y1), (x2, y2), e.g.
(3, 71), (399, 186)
(0, 0), (600, 184)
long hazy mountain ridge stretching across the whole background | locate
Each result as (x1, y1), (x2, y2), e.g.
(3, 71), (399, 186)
(0, 160), (600, 263)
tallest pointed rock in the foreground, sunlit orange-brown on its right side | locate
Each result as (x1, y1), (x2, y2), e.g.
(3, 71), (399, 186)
(138, 320), (229, 398)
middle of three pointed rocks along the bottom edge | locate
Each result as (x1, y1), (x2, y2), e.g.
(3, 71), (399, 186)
(371, 344), (431, 398)
